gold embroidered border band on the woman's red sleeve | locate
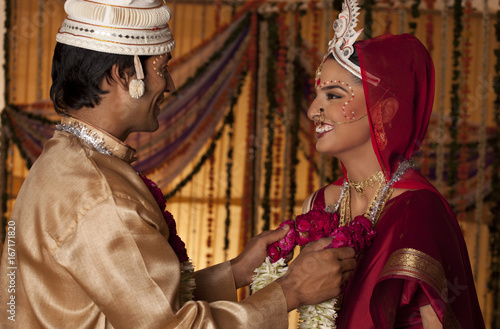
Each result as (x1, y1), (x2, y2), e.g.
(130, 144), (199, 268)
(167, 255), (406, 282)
(379, 248), (448, 302)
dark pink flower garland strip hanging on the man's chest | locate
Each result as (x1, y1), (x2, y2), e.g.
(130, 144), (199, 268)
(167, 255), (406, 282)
(139, 175), (189, 263)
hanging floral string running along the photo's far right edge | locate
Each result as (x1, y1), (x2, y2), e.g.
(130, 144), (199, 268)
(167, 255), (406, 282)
(488, 10), (500, 328)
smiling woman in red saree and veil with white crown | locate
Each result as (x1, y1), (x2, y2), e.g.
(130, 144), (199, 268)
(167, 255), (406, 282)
(254, 0), (484, 329)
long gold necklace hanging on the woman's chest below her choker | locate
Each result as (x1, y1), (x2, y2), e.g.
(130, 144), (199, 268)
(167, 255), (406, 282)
(340, 171), (394, 226)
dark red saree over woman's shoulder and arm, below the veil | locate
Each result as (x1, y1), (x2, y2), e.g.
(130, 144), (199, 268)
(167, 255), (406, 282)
(313, 188), (484, 329)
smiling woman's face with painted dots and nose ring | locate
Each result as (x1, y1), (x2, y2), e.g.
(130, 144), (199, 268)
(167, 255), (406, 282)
(307, 59), (371, 157)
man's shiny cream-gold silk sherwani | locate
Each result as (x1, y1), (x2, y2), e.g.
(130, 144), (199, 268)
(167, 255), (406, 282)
(0, 118), (288, 329)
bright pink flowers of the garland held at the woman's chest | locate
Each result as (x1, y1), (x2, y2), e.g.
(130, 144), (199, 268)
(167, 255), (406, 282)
(267, 208), (376, 263)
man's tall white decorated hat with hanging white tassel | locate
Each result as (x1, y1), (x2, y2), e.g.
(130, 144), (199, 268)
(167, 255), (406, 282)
(56, 0), (175, 98)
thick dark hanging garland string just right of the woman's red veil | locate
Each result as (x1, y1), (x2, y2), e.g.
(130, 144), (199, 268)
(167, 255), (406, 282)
(447, 0), (463, 197)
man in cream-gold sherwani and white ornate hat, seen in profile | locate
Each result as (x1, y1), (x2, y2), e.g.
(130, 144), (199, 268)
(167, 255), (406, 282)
(0, 0), (355, 329)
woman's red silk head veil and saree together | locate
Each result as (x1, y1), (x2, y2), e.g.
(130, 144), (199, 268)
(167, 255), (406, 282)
(326, 34), (484, 328)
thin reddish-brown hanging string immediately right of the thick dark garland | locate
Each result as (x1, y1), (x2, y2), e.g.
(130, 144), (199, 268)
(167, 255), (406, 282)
(457, 0), (472, 222)
